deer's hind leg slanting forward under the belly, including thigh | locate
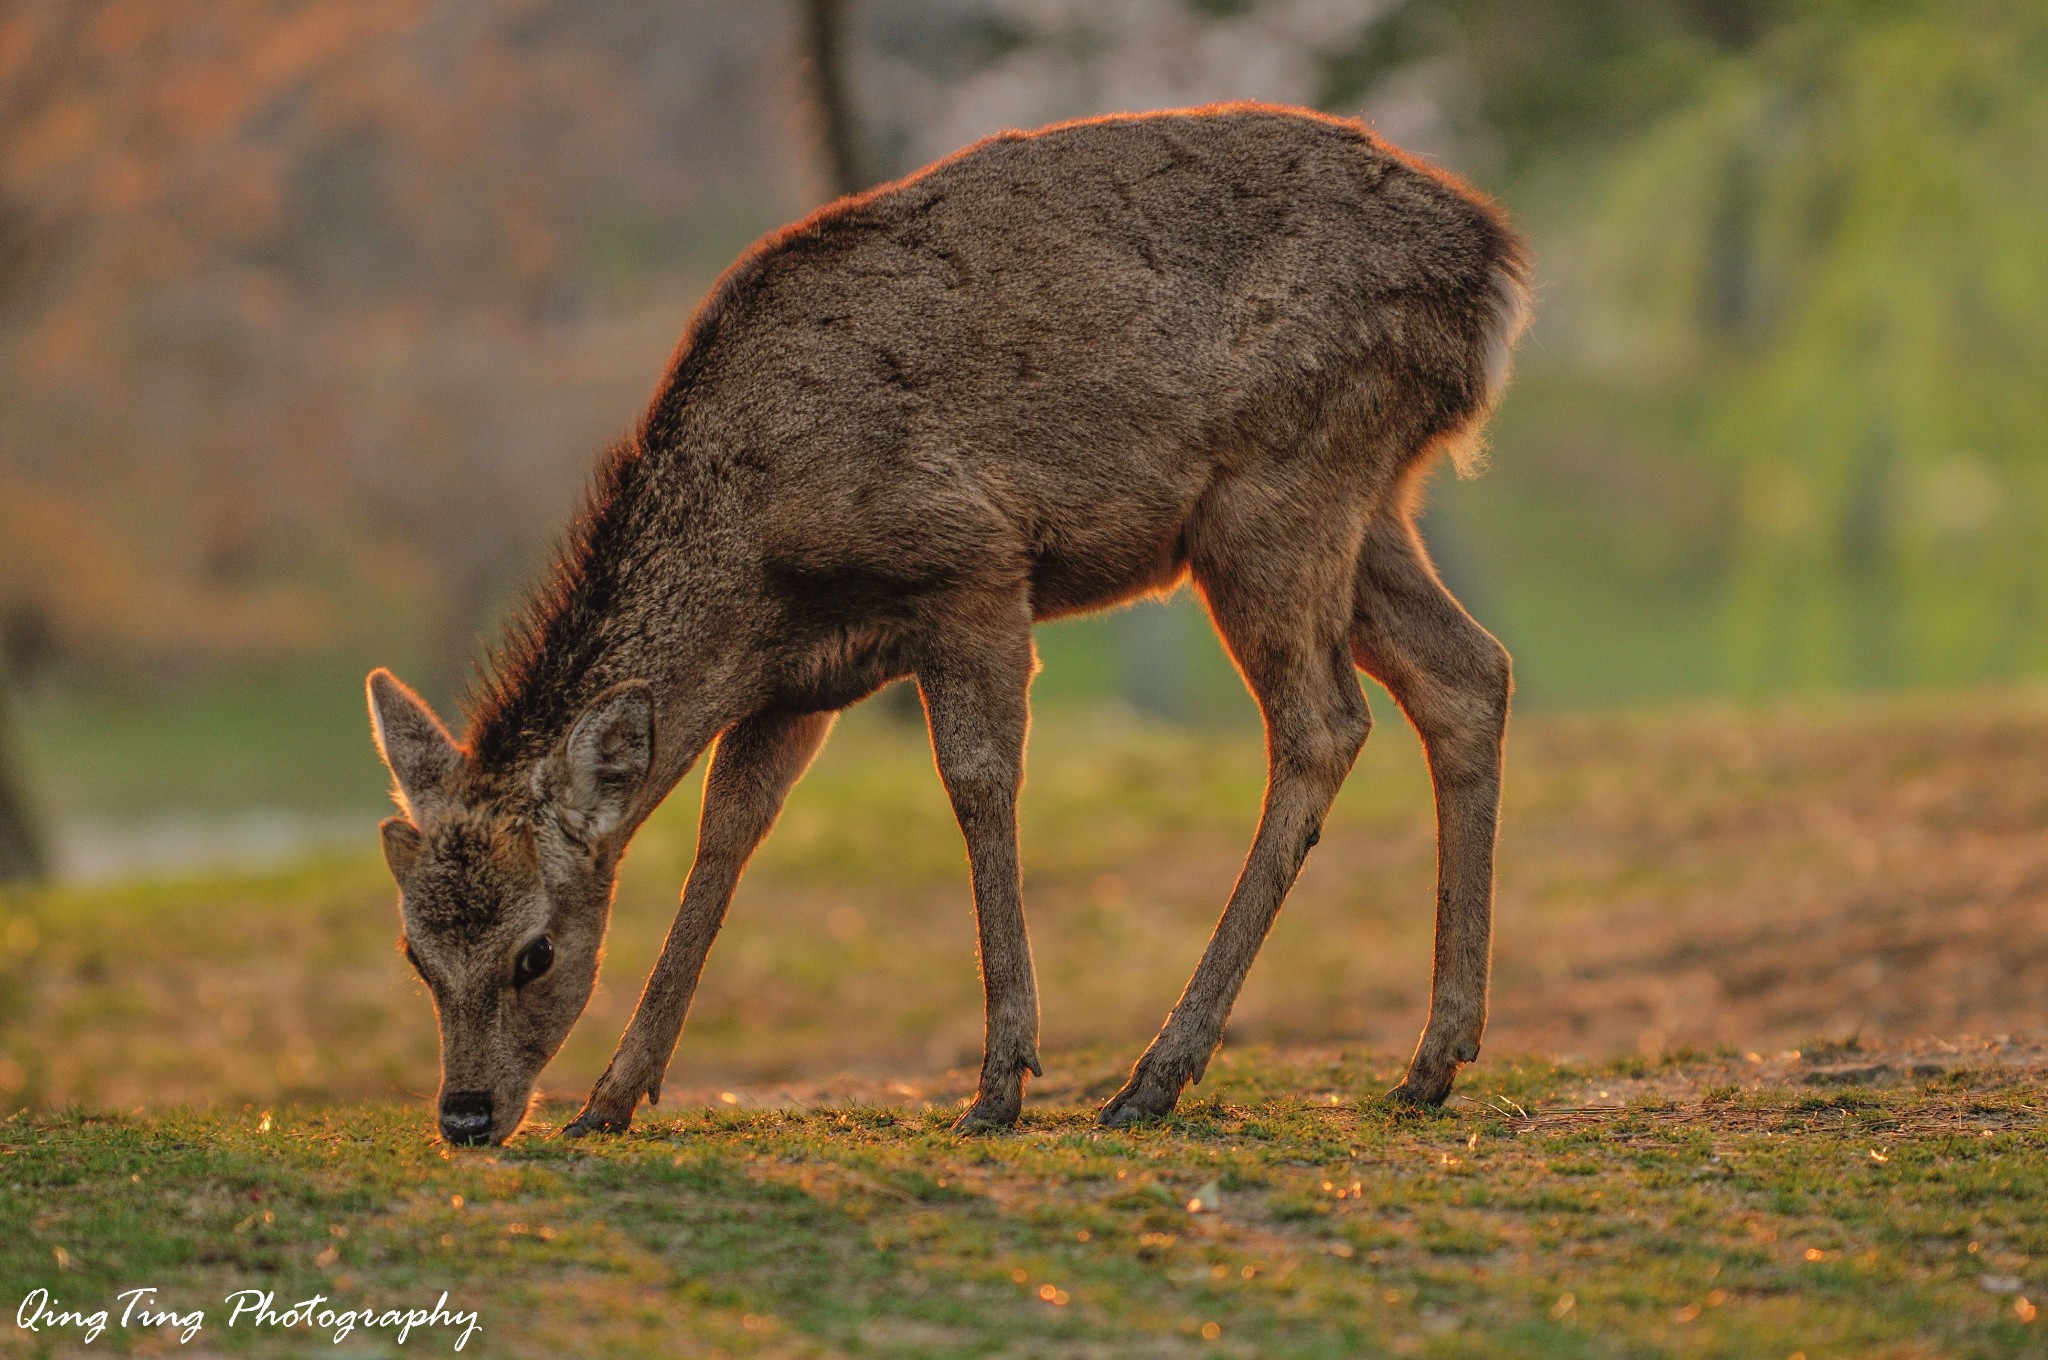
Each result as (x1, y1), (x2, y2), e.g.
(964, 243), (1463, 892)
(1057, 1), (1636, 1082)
(1102, 477), (1372, 1127)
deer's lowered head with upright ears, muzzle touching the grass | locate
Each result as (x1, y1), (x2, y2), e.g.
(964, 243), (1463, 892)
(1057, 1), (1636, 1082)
(369, 670), (653, 1143)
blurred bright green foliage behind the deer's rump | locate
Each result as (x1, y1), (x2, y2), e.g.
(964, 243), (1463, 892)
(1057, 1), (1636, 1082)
(1441, 2), (2048, 698)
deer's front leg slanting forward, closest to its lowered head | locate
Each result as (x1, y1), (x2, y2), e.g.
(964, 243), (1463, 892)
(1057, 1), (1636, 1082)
(563, 713), (834, 1137)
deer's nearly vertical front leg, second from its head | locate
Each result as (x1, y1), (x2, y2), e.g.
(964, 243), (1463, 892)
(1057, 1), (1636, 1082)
(918, 622), (1042, 1131)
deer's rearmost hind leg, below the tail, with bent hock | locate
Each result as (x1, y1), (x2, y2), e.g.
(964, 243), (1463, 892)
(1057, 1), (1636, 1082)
(1352, 504), (1513, 1104)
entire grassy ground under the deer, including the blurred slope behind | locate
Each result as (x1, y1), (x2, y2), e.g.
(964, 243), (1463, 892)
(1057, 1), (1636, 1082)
(0, 690), (2048, 1360)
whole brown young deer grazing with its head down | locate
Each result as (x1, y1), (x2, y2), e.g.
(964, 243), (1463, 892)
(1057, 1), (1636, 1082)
(369, 104), (1526, 1143)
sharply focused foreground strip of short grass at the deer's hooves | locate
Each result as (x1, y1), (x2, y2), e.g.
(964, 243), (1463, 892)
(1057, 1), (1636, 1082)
(0, 1049), (2048, 1360)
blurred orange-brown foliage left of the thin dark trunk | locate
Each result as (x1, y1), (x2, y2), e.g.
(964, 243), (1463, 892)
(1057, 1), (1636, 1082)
(0, 0), (807, 680)
